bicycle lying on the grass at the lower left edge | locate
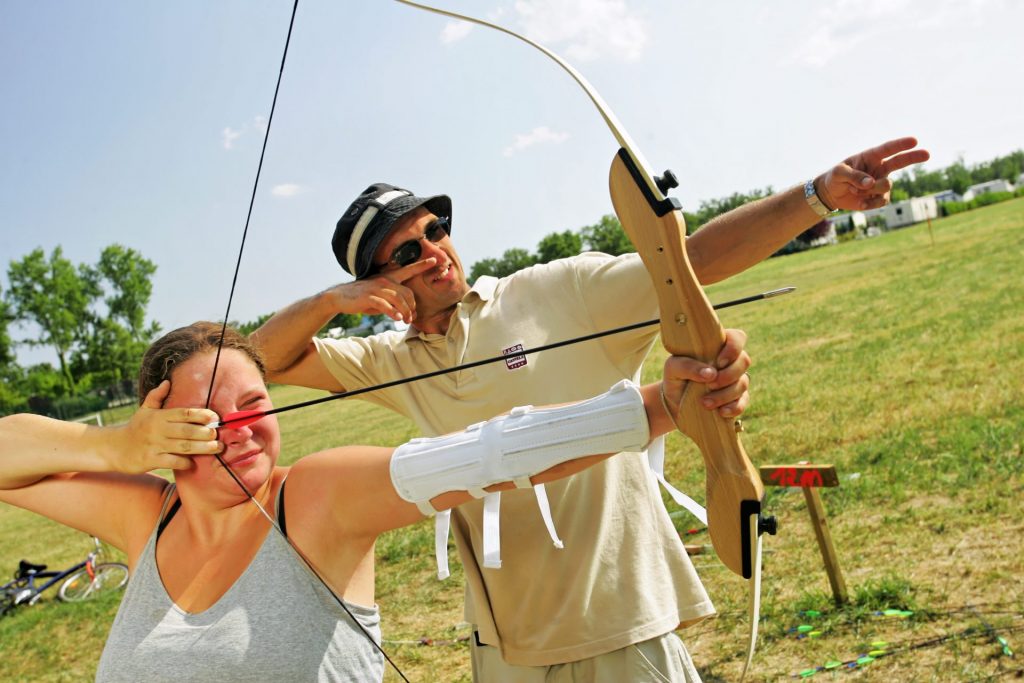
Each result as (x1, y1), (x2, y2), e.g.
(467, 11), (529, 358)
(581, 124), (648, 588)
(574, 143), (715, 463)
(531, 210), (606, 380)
(0, 537), (128, 616)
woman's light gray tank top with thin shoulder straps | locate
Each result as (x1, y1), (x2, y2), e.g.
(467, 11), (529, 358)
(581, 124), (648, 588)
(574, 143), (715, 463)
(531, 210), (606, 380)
(96, 485), (384, 683)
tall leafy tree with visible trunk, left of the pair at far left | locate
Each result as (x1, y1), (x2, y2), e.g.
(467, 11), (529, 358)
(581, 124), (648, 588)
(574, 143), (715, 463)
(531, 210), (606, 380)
(7, 247), (99, 395)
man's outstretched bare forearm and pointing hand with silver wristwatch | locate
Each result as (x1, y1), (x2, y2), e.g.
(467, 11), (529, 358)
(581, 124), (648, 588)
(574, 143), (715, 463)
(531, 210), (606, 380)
(686, 137), (929, 285)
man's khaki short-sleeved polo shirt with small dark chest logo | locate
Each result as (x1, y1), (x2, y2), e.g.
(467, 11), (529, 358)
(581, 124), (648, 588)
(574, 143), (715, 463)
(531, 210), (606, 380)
(316, 253), (714, 666)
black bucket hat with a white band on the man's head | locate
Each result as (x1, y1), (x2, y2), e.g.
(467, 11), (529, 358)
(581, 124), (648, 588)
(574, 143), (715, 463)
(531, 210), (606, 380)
(331, 182), (452, 280)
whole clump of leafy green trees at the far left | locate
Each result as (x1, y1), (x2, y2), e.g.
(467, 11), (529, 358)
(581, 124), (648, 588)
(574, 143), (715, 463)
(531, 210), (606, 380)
(0, 244), (160, 418)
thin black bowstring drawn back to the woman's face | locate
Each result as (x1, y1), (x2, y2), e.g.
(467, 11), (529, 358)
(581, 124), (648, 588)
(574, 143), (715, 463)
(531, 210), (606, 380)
(199, 0), (409, 683)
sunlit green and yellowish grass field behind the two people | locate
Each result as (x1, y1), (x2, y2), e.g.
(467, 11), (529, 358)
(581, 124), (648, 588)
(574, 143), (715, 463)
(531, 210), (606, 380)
(0, 200), (1024, 681)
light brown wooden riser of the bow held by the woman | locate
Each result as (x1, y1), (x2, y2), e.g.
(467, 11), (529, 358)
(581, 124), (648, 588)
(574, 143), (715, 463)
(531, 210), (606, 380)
(609, 153), (764, 579)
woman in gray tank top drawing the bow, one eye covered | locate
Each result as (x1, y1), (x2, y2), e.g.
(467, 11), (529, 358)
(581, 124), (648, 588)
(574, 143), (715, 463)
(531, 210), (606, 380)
(0, 323), (750, 683)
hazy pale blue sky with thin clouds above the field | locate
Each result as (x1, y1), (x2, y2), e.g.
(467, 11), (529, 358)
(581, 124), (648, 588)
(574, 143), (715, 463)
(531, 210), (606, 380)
(0, 0), (1024, 364)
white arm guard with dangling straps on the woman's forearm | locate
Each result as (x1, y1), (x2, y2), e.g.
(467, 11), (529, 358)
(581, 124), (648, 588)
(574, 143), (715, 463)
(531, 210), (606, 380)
(391, 380), (649, 578)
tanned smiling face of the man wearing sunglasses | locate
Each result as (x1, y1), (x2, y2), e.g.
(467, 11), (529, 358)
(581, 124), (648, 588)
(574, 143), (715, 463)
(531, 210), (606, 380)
(373, 207), (469, 327)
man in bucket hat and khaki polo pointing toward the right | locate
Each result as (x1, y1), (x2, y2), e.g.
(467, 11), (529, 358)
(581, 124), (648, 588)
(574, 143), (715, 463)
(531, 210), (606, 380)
(254, 138), (928, 682)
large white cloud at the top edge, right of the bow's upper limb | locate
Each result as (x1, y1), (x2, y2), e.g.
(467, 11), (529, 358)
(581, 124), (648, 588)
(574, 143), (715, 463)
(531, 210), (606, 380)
(515, 0), (647, 61)
